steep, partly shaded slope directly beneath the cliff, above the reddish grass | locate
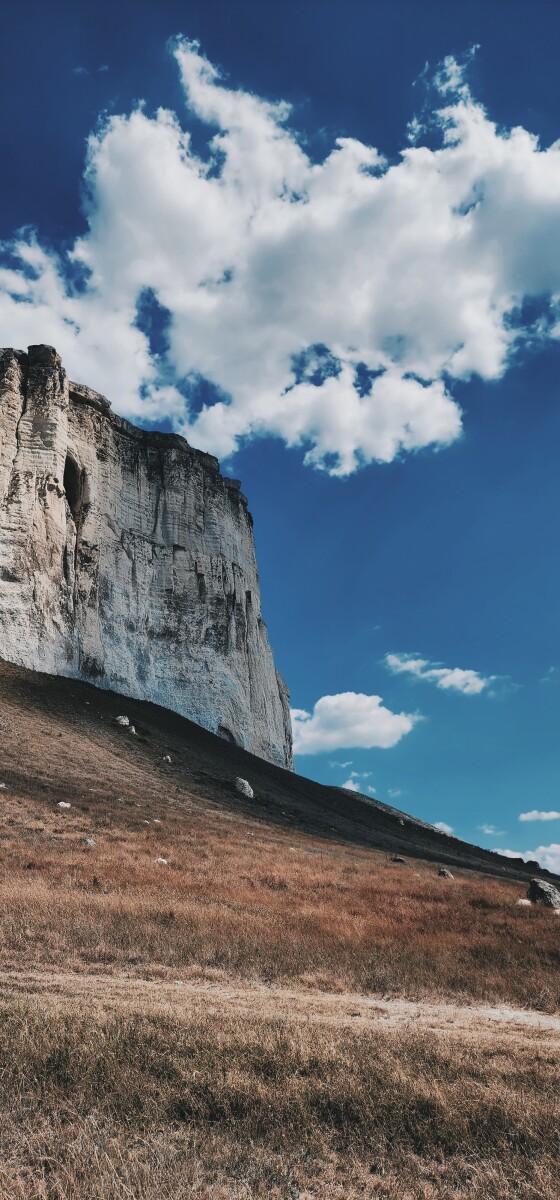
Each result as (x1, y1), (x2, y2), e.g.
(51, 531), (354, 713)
(0, 660), (552, 881)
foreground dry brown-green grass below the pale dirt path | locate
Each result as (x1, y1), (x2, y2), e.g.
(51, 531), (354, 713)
(0, 1002), (560, 1200)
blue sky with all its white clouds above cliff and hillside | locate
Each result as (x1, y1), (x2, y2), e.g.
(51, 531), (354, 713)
(0, 0), (560, 870)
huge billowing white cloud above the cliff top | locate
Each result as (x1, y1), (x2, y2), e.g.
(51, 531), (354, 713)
(0, 40), (560, 475)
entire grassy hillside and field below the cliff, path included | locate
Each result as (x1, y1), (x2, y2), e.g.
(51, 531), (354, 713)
(0, 662), (560, 1200)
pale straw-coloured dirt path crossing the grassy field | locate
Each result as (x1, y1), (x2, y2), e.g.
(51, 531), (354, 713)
(0, 970), (560, 1046)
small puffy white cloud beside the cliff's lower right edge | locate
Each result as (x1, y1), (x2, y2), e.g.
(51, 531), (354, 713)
(291, 691), (420, 753)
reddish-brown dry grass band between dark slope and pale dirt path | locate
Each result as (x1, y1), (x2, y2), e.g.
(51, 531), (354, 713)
(0, 802), (560, 1012)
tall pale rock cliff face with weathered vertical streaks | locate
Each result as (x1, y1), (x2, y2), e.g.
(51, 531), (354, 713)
(0, 346), (293, 767)
